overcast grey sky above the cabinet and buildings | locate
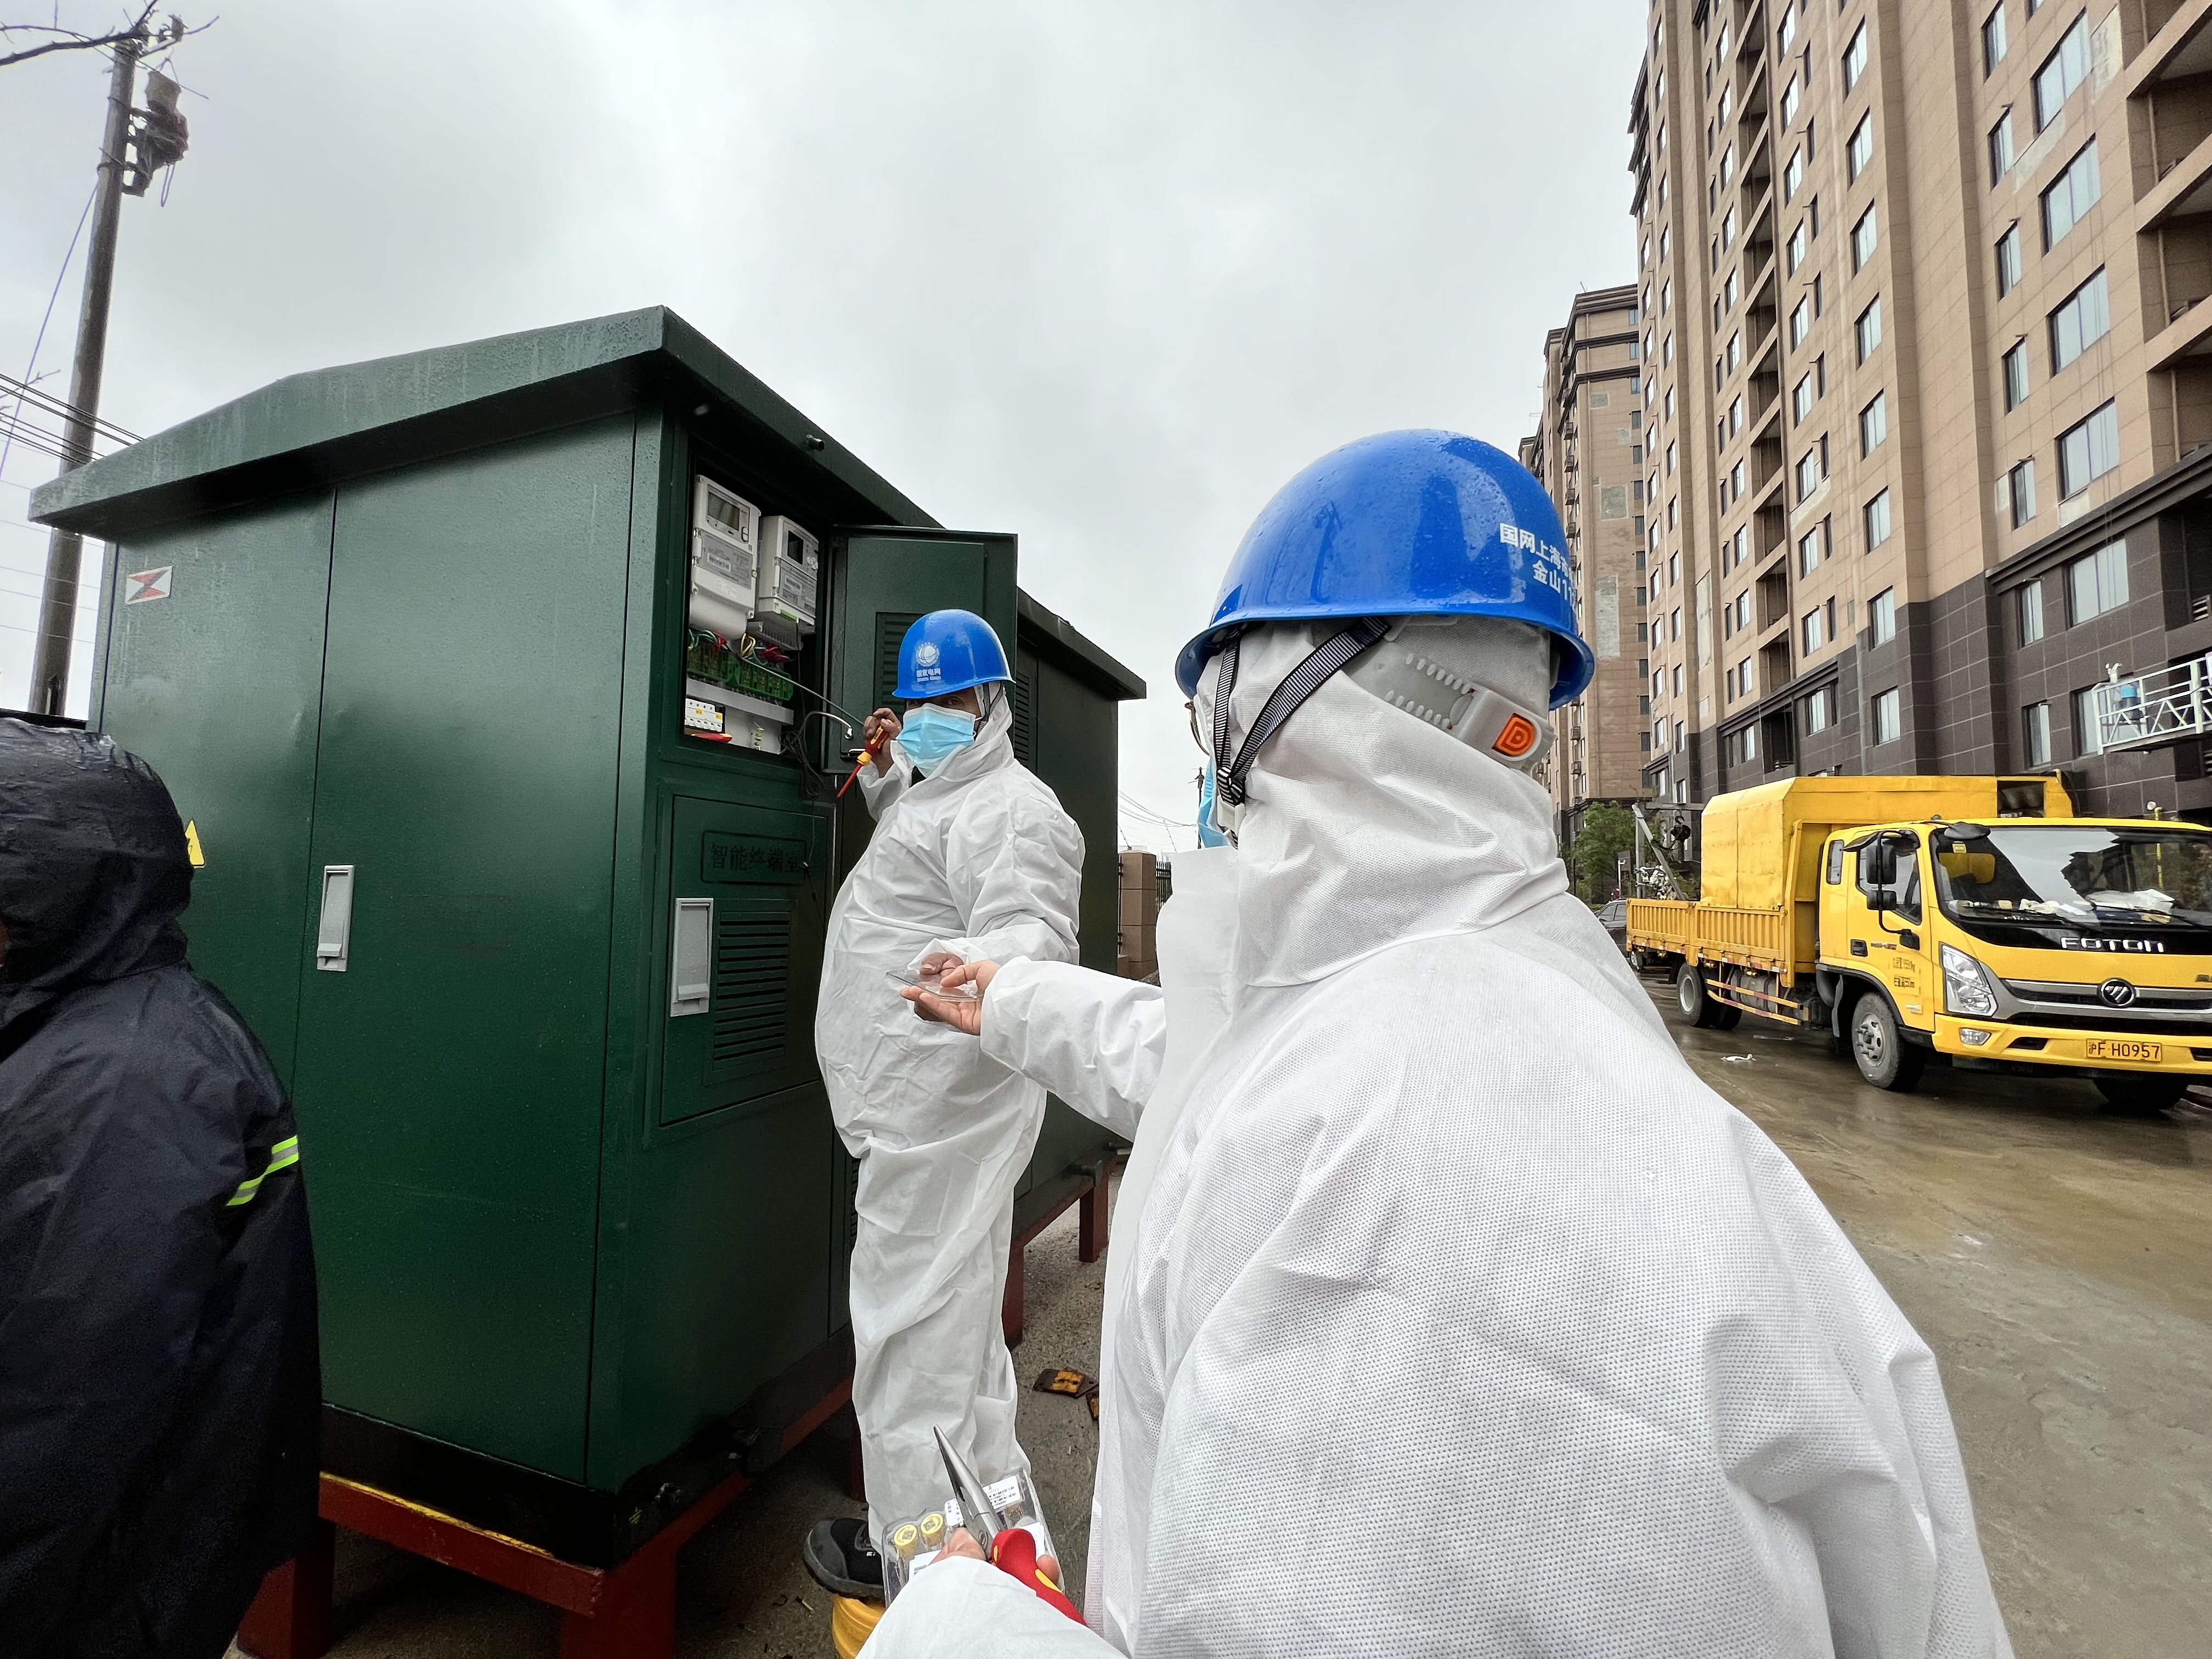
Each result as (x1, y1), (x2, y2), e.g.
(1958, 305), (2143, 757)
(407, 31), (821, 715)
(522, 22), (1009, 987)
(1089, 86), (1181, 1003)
(0, 0), (1644, 851)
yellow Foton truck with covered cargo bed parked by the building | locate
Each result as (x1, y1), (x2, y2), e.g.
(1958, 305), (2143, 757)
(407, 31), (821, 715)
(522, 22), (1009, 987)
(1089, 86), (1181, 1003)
(1626, 776), (2212, 1113)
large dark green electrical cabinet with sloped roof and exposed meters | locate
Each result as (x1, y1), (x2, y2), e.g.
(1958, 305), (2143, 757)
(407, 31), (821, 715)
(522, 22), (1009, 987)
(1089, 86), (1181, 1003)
(33, 309), (1144, 1564)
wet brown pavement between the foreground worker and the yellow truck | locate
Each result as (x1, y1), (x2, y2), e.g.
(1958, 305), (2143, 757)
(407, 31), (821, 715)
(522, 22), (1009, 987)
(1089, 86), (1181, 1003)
(1646, 978), (2212, 1659)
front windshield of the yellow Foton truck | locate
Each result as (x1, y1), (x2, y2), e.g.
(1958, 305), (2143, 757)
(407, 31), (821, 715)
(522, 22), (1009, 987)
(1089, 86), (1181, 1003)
(1931, 823), (2212, 929)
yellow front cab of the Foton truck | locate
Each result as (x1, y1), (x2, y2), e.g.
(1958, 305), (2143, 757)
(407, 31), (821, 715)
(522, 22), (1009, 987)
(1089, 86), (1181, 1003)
(1816, 819), (2212, 1110)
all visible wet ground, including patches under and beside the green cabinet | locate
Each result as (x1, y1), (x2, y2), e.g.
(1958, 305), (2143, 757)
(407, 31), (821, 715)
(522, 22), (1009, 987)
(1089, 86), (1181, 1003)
(251, 995), (2212, 1659)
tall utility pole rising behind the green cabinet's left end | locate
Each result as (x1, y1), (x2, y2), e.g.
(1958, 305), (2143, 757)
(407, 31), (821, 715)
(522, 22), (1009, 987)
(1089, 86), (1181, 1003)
(31, 24), (146, 714)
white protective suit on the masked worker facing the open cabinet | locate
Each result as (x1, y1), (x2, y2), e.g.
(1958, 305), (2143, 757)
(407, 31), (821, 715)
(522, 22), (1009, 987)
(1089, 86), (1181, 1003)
(814, 688), (1084, 1539)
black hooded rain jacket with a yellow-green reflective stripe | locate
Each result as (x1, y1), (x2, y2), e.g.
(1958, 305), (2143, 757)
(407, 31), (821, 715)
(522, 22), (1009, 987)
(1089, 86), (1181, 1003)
(0, 719), (321, 1659)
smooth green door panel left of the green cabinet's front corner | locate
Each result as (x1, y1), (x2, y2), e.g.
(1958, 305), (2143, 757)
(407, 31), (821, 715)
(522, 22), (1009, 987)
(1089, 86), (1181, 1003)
(296, 418), (633, 1477)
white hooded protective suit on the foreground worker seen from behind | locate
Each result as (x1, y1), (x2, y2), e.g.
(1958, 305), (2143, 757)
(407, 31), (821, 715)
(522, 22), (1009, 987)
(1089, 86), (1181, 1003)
(870, 628), (2011, 1659)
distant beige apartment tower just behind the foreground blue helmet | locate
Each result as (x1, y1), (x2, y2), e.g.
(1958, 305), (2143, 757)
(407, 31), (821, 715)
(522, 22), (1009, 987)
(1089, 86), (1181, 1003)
(1520, 285), (1650, 840)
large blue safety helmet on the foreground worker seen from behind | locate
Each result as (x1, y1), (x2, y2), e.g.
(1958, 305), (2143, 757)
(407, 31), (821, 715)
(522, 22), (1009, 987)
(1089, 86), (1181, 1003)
(1175, 431), (1597, 708)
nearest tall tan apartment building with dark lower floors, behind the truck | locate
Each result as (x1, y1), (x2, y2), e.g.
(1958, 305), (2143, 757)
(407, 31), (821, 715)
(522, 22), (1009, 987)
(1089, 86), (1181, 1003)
(1630, 0), (2212, 821)
